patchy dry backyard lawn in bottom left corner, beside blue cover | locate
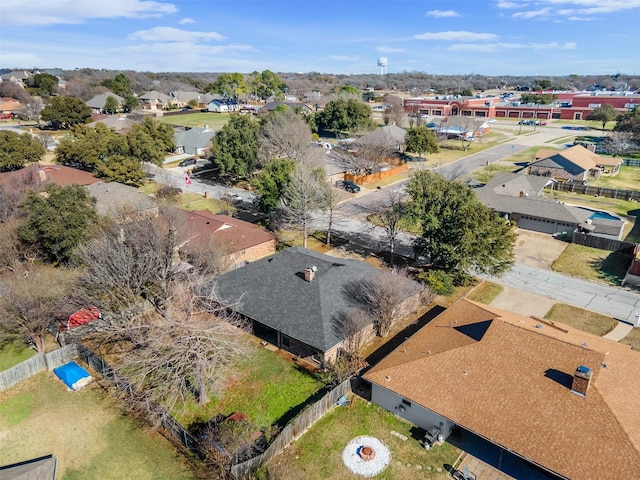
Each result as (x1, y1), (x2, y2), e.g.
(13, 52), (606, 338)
(0, 372), (195, 480)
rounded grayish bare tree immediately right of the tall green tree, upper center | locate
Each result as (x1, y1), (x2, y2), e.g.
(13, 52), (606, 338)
(258, 109), (322, 164)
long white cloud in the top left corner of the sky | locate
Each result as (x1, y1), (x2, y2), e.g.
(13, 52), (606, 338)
(0, 0), (178, 26)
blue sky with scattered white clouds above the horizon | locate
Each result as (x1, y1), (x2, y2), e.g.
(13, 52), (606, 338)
(0, 0), (640, 76)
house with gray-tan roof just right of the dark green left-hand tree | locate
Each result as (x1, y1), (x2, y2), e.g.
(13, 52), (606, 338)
(86, 182), (158, 218)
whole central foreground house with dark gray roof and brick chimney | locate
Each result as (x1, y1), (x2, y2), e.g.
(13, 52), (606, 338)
(217, 247), (421, 366)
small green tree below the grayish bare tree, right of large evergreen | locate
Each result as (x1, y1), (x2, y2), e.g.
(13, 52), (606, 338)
(251, 158), (296, 212)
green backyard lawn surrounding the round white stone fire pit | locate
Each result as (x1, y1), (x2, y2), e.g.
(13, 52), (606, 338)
(257, 396), (460, 480)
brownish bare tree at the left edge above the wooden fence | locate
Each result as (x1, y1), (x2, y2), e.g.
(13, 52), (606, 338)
(0, 265), (73, 353)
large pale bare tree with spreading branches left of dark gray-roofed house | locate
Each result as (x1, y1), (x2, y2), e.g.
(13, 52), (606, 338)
(117, 277), (250, 411)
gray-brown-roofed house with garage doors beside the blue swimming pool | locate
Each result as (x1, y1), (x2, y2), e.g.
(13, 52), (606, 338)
(474, 172), (626, 240)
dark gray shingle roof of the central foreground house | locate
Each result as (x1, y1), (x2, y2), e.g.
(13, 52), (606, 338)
(218, 247), (416, 352)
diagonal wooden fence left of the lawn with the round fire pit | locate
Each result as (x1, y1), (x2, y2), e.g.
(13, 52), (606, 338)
(231, 379), (351, 479)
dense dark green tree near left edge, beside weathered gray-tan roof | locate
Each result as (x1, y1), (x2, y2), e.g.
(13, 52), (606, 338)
(18, 183), (98, 263)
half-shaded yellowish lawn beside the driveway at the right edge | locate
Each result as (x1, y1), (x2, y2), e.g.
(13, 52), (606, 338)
(551, 244), (631, 285)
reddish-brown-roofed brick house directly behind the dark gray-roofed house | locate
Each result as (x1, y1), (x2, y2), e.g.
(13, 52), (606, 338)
(179, 210), (276, 270)
